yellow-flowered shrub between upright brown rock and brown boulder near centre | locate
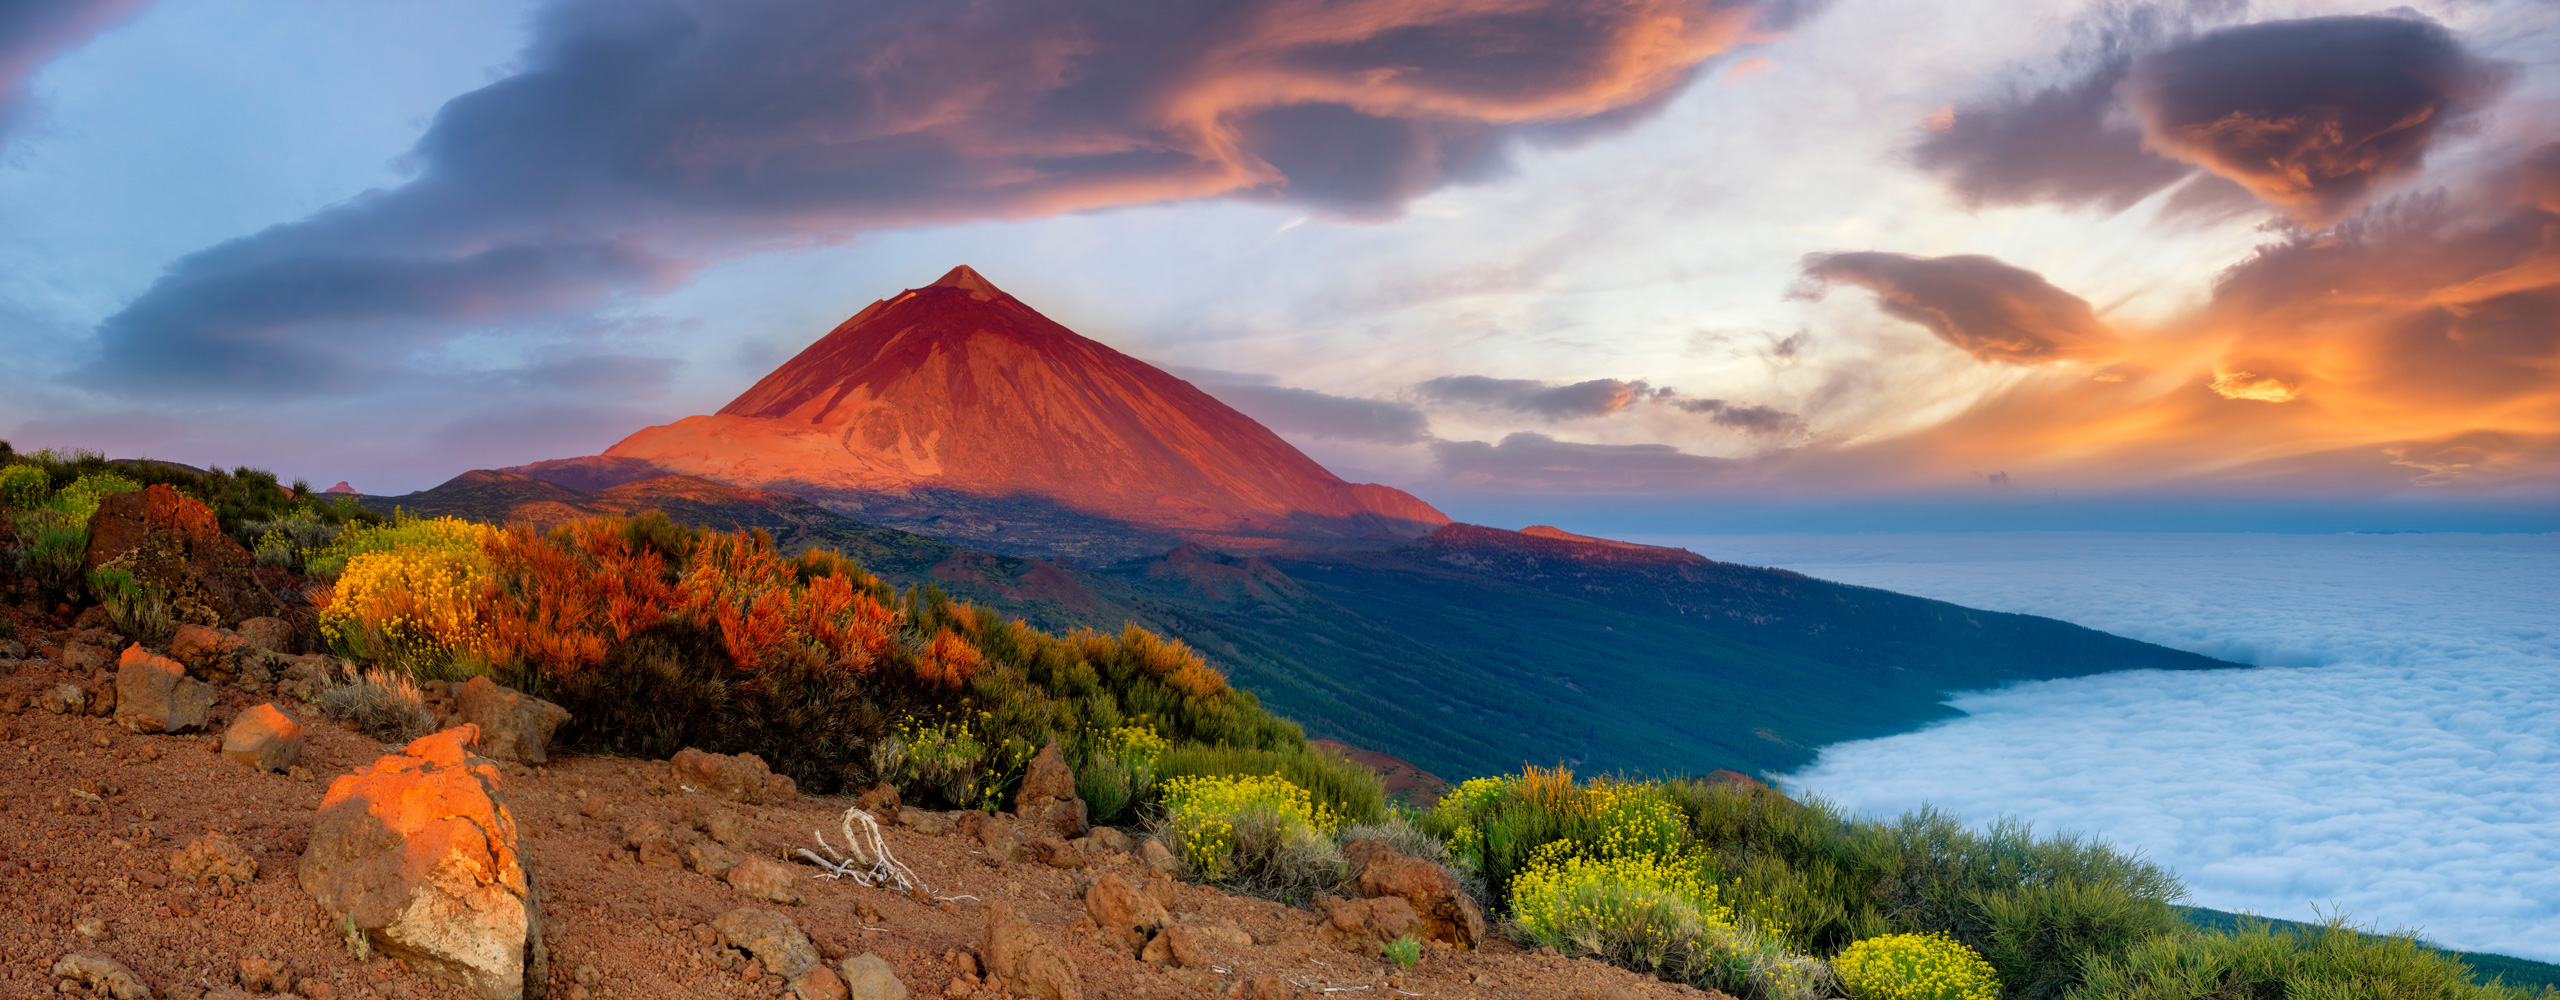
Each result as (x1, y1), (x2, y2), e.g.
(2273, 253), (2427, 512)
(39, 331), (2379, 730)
(1160, 775), (1341, 900)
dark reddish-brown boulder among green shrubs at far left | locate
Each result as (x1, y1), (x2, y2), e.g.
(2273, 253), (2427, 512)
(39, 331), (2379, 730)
(82, 486), (279, 627)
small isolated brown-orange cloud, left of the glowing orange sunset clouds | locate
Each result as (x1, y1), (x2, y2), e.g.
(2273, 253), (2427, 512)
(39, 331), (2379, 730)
(1797, 251), (2117, 363)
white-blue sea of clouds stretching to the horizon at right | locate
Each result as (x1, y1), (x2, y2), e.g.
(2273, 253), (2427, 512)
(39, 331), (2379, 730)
(1638, 532), (2560, 962)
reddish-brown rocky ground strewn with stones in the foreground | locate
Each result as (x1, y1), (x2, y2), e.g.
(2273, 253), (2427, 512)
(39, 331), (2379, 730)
(0, 616), (1697, 1000)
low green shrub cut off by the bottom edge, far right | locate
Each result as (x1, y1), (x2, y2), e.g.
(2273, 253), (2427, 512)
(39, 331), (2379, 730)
(2068, 916), (2527, 1000)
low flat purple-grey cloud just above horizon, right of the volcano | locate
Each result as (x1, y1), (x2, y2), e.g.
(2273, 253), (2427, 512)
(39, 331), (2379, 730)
(1431, 432), (1738, 494)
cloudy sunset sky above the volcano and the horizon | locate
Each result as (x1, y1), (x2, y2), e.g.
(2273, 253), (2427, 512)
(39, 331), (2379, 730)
(0, 0), (2560, 532)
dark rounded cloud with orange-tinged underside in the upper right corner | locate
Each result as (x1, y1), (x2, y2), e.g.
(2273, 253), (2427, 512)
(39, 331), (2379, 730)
(2125, 18), (2506, 225)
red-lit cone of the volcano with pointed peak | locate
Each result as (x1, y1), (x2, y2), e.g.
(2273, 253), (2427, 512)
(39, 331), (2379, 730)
(558, 266), (1449, 558)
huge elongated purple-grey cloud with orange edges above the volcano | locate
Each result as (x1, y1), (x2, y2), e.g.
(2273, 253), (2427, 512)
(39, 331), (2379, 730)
(87, 0), (1800, 394)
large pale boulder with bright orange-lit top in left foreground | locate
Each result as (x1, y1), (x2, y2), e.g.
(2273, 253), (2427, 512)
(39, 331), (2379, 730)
(302, 724), (548, 1000)
